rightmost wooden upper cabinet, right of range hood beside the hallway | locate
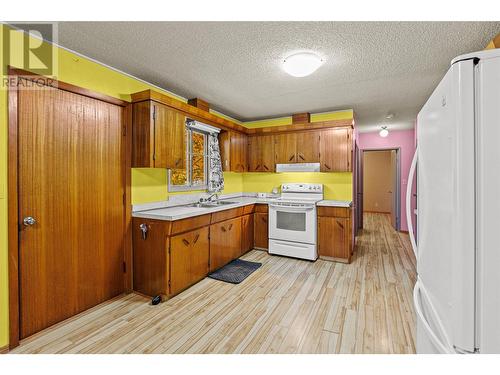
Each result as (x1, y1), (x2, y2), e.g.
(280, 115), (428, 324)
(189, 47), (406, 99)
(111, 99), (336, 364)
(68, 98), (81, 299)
(320, 128), (352, 172)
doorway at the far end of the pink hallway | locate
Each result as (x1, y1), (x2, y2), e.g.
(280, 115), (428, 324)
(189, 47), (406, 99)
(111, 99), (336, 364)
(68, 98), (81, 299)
(358, 148), (401, 231)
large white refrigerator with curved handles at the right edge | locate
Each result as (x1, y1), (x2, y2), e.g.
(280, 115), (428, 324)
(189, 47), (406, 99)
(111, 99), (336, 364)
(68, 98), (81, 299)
(407, 49), (500, 353)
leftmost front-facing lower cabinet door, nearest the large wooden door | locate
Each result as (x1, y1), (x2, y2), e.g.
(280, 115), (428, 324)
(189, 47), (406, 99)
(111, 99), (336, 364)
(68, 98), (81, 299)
(170, 232), (193, 294)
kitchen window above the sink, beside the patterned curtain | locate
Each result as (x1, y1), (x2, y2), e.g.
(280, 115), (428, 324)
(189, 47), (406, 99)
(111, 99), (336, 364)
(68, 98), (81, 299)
(168, 126), (208, 191)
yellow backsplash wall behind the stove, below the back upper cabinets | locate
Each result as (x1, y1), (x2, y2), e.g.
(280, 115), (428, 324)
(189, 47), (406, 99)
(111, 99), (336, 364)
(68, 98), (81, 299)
(243, 172), (352, 201)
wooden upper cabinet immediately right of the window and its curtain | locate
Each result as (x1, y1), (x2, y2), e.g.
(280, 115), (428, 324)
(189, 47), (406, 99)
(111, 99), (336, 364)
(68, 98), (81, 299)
(219, 131), (248, 172)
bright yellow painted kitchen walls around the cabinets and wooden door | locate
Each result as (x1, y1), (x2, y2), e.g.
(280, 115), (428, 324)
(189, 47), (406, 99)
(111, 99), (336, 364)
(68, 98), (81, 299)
(0, 25), (352, 348)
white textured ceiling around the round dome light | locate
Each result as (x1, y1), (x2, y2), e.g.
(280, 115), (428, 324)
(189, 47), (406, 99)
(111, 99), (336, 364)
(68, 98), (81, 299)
(59, 22), (500, 131)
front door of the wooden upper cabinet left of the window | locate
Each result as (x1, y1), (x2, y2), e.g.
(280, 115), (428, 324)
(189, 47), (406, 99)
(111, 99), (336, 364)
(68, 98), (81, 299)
(153, 104), (186, 169)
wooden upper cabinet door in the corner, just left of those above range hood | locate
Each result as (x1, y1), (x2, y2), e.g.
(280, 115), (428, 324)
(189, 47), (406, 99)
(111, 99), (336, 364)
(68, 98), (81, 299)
(248, 135), (275, 172)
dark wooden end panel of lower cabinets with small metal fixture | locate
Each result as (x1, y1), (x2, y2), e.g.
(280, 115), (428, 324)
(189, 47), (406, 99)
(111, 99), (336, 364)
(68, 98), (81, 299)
(132, 217), (171, 297)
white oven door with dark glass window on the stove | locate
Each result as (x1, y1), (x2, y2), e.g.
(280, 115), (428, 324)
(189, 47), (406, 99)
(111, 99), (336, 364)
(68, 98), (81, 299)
(269, 204), (316, 244)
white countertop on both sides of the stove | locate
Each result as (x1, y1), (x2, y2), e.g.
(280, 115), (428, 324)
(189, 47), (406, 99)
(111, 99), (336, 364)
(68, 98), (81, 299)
(132, 196), (351, 221)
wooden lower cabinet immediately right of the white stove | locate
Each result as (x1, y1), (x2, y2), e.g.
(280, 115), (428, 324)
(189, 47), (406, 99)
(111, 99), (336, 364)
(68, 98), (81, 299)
(318, 207), (352, 263)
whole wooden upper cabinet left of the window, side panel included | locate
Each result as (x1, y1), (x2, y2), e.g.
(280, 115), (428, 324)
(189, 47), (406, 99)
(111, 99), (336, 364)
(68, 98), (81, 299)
(132, 101), (186, 169)
